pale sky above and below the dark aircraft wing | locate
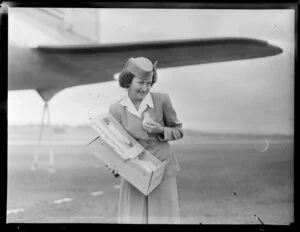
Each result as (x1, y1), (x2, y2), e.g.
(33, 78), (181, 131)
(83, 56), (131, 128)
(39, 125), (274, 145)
(8, 9), (294, 134)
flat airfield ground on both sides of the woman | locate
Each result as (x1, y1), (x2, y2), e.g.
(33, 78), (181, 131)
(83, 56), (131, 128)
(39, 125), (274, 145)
(7, 126), (294, 225)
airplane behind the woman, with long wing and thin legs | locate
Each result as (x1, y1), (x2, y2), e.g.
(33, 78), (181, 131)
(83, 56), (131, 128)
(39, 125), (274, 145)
(8, 8), (283, 172)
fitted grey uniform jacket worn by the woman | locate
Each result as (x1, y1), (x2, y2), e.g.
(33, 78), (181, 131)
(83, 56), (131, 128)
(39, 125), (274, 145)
(109, 92), (183, 175)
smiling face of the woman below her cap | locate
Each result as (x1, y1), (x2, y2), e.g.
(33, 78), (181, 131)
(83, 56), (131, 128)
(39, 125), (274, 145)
(128, 76), (152, 101)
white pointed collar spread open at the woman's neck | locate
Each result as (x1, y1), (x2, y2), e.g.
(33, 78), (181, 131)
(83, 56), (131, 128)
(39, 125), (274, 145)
(119, 93), (154, 118)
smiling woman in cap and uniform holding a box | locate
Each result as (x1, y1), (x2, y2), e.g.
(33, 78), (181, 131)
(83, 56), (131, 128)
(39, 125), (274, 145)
(109, 57), (183, 224)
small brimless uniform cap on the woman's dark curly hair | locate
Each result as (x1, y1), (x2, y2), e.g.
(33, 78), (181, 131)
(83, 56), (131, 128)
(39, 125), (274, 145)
(125, 57), (157, 78)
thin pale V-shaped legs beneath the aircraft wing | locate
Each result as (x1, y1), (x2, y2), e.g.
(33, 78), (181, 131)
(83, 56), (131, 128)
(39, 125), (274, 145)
(31, 101), (55, 173)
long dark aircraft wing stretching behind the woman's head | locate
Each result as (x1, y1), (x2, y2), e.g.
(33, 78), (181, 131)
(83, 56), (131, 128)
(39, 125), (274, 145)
(8, 38), (282, 100)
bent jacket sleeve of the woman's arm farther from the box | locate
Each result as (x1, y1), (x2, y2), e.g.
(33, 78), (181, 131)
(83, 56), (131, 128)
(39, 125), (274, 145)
(158, 94), (183, 141)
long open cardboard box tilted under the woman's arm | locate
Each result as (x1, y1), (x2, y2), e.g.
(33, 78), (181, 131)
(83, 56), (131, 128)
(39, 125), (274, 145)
(86, 113), (166, 195)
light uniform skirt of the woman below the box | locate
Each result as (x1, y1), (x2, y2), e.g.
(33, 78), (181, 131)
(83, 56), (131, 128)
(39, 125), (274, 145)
(118, 175), (180, 224)
